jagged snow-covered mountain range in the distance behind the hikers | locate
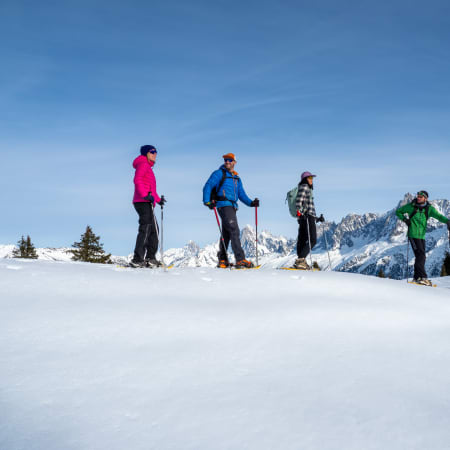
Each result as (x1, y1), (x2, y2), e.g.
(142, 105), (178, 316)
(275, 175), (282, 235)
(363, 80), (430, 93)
(0, 194), (450, 279)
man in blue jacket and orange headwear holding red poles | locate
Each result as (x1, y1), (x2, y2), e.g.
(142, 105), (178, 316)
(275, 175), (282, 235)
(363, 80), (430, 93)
(203, 153), (259, 269)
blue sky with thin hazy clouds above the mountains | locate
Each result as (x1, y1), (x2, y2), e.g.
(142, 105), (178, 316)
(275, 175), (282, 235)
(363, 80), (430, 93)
(0, 0), (450, 254)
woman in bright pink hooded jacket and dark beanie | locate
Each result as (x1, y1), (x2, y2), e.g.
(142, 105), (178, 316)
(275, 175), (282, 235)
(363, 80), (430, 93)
(130, 145), (166, 267)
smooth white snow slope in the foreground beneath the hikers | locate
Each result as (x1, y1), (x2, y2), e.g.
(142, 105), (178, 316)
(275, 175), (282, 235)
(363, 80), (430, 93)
(0, 259), (450, 450)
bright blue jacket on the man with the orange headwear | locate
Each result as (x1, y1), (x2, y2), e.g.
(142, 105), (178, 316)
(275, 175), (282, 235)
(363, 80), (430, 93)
(203, 165), (252, 209)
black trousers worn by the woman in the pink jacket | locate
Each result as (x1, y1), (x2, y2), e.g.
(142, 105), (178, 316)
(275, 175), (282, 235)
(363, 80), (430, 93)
(133, 202), (158, 261)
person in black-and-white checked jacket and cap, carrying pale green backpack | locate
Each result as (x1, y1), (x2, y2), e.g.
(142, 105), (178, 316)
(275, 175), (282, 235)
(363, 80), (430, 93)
(294, 172), (325, 270)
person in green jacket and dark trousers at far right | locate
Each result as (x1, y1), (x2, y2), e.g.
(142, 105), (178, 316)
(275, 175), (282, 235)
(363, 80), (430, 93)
(395, 191), (450, 286)
